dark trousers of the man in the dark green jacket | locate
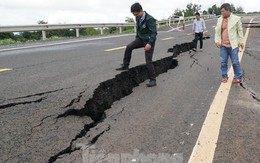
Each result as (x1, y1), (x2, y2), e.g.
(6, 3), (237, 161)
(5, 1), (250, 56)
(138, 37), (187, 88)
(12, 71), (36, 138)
(123, 38), (156, 79)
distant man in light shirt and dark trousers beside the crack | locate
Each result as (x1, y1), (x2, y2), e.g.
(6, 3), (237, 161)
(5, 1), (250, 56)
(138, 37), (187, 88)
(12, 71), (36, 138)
(192, 12), (206, 51)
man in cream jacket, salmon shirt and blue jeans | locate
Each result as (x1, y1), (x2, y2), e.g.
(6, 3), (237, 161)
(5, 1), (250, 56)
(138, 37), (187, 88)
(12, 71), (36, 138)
(215, 3), (244, 83)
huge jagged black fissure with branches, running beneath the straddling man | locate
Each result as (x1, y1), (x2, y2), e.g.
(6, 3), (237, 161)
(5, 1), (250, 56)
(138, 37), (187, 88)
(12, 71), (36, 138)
(49, 42), (193, 162)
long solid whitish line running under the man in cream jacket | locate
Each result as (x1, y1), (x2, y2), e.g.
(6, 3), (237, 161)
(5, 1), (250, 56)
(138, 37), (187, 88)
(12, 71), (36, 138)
(189, 19), (253, 163)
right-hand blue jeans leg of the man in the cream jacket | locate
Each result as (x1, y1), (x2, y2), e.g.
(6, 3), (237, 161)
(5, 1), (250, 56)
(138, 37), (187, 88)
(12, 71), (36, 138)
(230, 47), (242, 80)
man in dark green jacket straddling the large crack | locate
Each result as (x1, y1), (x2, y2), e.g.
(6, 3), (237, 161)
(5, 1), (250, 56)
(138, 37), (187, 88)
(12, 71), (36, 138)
(116, 3), (157, 87)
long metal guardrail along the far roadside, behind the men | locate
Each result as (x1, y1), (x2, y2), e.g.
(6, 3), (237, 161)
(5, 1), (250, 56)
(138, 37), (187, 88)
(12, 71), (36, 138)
(0, 15), (215, 40)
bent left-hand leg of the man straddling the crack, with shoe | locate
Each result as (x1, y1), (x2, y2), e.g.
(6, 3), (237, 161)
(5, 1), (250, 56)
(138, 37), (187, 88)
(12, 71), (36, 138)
(116, 38), (144, 70)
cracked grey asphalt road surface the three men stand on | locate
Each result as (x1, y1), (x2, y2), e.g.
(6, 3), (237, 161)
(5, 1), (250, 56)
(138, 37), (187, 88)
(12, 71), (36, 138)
(0, 17), (260, 163)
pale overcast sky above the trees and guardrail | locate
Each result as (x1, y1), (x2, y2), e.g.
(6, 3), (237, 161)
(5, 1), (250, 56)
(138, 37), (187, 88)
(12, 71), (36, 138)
(0, 0), (260, 26)
